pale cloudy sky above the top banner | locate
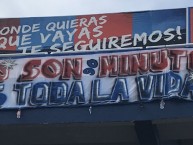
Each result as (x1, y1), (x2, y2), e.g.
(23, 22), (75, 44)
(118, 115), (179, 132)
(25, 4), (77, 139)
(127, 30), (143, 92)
(0, 0), (193, 18)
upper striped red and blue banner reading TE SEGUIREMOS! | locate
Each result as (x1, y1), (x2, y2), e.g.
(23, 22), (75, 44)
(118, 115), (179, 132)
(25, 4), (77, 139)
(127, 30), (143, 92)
(0, 8), (189, 54)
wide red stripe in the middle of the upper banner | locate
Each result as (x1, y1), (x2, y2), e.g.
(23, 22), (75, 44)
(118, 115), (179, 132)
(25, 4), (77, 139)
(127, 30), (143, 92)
(74, 13), (132, 43)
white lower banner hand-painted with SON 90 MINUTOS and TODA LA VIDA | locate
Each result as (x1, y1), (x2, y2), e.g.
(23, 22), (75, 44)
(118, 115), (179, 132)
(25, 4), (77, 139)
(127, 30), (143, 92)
(0, 48), (193, 108)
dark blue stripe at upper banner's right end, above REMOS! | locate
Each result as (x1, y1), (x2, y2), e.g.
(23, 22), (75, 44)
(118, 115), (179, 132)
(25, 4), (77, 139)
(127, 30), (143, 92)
(133, 9), (186, 35)
